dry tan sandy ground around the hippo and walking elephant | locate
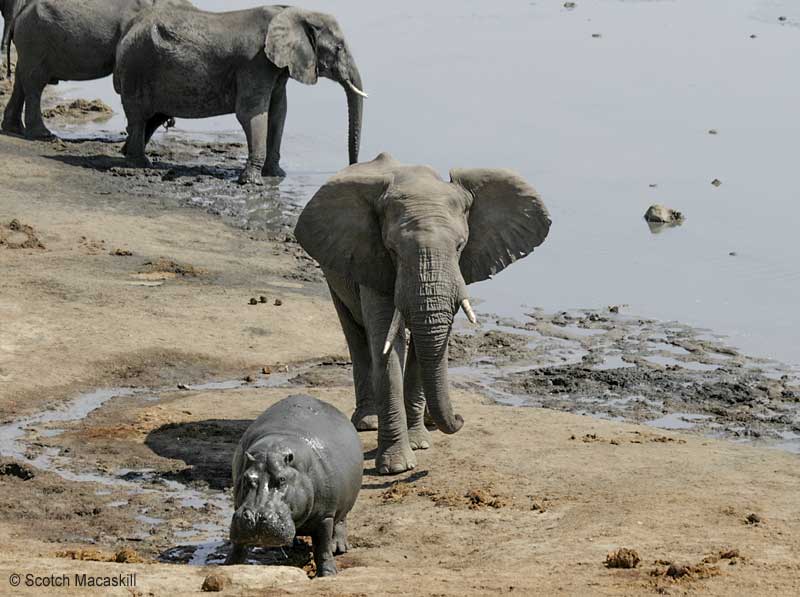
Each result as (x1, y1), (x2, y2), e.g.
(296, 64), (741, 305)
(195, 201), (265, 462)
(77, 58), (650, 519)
(0, 125), (800, 595)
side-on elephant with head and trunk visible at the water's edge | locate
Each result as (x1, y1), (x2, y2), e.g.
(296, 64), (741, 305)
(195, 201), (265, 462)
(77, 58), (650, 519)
(114, 6), (364, 184)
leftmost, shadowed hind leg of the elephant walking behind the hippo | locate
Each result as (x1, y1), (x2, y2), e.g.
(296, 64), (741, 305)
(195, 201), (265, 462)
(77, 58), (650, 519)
(331, 288), (378, 431)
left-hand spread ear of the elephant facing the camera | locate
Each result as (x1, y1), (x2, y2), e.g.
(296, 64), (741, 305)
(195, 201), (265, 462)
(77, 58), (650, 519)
(294, 172), (395, 294)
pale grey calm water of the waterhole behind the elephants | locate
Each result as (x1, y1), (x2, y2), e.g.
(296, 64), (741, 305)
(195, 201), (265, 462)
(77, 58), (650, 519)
(42, 0), (800, 363)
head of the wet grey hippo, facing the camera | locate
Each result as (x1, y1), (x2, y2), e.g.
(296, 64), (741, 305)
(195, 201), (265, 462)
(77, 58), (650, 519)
(231, 445), (314, 547)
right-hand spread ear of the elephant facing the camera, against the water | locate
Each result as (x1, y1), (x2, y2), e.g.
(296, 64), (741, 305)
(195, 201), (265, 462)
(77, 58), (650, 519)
(450, 169), (551, 284)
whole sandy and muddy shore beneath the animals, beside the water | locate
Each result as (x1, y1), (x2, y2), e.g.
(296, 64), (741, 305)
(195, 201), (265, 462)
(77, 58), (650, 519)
(0, 101), (800, 595)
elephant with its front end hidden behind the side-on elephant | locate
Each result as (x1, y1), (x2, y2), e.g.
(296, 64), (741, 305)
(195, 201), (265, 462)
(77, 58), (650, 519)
(2, 0), (192, 139)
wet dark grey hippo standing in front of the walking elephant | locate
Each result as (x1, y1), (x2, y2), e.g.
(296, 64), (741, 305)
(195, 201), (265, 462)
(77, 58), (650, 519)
(225, 395), (364, 576)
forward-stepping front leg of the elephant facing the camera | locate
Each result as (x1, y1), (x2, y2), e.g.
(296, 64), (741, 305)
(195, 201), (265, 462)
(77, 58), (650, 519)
(361, 286), (417, 475)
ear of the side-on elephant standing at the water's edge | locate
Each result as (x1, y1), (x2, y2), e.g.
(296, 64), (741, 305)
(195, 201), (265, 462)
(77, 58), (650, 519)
(264, 7), (317, 85)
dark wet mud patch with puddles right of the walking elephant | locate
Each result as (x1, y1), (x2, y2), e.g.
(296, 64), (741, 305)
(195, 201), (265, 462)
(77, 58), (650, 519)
(451, 308), (800, 452)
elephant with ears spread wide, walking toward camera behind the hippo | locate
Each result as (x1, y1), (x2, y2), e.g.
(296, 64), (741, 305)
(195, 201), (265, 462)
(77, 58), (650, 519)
(295, 154), (550, 474)
